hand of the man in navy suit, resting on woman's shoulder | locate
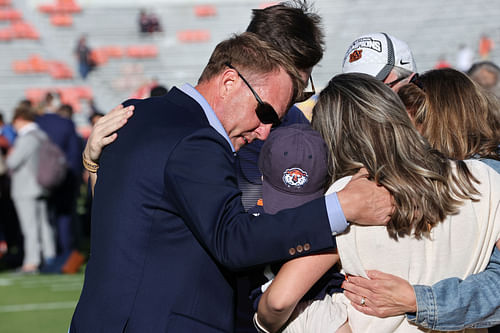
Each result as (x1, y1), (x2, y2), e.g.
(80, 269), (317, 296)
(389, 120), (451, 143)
(337, 169), (394, 225)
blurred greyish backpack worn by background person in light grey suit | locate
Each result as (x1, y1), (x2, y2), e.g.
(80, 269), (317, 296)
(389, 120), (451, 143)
(37, 138), (67, 190)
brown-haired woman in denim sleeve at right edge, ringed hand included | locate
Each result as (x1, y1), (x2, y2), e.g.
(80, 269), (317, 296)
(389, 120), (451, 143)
(343, 68), (500, 330)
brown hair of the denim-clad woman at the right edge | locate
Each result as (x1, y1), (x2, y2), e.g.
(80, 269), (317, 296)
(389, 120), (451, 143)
(398, 68), (500, 160)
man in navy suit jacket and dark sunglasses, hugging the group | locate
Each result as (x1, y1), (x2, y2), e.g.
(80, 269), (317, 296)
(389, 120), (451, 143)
(70, 33), (391, 333)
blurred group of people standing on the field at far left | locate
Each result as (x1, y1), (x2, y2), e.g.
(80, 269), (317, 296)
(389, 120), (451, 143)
(0, 93), (93, 274)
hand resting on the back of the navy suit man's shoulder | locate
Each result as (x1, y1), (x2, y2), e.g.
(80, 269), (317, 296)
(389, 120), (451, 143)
(83, 105), (134, 163)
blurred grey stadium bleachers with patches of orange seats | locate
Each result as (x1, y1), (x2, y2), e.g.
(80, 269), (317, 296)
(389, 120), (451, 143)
(0, 0), (500, 135)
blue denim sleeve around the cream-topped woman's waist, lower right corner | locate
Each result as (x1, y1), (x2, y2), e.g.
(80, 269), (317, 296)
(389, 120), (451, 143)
(406, 247), (500, 331)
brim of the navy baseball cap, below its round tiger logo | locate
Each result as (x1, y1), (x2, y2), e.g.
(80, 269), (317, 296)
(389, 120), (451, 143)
(262, 181), (323, 214)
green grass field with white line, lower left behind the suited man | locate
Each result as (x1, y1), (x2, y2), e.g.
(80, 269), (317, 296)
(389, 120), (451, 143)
(0, 273), (83, 333)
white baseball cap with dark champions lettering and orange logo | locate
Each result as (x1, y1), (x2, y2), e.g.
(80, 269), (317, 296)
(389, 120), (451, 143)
(342, 32), (417, 80)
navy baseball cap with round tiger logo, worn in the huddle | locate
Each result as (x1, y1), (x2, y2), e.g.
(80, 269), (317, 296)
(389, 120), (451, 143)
(259, 124), (328, 214)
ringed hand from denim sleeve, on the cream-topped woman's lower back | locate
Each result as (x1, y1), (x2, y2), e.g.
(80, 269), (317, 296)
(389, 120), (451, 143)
(342, 271), (417, 318)
